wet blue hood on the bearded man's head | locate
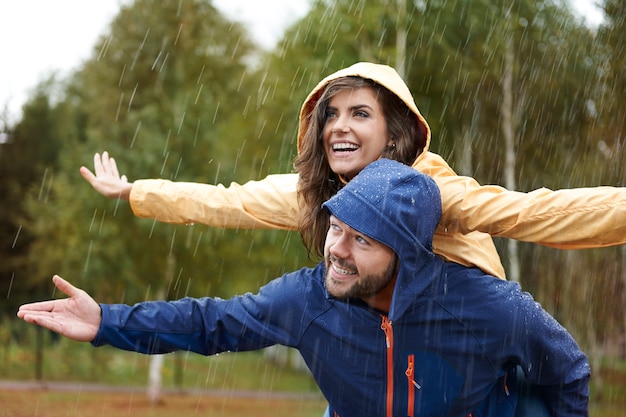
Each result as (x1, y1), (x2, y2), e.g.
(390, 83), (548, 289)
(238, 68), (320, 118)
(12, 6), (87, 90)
(323, 158), (441, 313)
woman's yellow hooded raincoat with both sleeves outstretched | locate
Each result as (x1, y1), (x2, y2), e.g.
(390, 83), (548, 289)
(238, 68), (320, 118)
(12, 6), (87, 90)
(130, 63), (626, 278)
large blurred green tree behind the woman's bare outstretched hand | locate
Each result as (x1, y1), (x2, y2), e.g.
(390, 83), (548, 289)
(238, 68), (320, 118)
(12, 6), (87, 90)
(20, 0), (308, 303)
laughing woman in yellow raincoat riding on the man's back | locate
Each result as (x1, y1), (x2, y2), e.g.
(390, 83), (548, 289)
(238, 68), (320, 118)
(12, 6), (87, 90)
(81, 62), (626, 278)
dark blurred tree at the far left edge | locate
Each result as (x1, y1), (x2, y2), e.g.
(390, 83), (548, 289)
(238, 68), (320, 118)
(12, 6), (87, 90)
(0, 82), (69, 318)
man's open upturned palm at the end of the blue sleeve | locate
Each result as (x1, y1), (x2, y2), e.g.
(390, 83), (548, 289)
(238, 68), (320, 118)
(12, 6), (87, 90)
(17, 275), (102, 342)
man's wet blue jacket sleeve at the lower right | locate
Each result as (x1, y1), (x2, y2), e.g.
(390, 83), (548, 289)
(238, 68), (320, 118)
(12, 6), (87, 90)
(458, 265), (591, 417)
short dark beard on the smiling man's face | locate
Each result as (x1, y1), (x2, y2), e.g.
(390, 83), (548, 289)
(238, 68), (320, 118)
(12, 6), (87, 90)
(324, 257), (398, 300)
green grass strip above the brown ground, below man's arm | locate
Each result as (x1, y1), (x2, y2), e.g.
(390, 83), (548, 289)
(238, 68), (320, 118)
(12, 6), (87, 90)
(0, 330), (319, 392)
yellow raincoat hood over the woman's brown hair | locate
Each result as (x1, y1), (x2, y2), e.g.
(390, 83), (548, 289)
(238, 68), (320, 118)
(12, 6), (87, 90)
(298, 62), (430, 156)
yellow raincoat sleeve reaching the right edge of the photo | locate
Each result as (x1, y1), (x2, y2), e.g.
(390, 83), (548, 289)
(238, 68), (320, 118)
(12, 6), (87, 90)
(414, 152), (626, 249)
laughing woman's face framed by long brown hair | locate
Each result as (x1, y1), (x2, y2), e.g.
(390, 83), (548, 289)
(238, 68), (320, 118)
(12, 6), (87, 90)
(323, 87), (392, 179)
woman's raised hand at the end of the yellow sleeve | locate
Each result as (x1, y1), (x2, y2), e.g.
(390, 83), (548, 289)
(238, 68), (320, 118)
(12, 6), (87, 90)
(80, 151), (133, 201)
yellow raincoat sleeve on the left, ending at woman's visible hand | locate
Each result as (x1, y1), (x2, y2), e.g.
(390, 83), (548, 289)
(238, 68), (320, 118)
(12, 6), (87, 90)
(130, 174), (298, 230)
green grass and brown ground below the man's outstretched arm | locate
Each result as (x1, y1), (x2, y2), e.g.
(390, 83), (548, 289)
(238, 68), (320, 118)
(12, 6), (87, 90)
(0, 333), (326, 417)
